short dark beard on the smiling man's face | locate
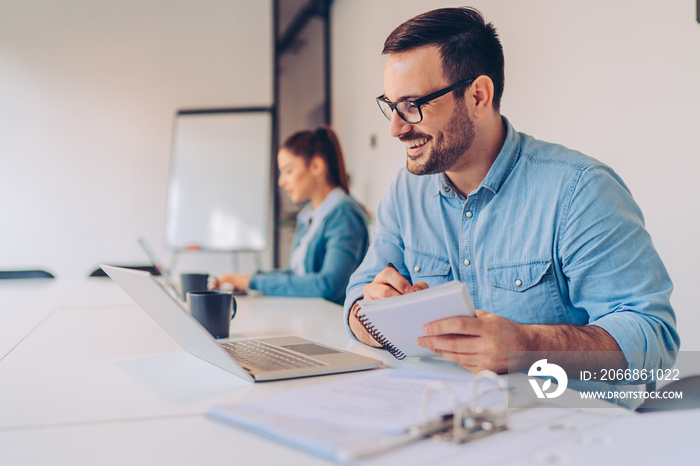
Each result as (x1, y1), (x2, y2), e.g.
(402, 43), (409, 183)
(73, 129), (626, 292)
(400, 99), (474, 175)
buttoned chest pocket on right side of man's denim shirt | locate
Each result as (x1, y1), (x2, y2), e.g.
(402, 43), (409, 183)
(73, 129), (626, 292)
(487, 259), (564, 324)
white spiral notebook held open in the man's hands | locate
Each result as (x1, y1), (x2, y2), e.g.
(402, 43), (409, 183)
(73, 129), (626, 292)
(358, 280), (476, 359)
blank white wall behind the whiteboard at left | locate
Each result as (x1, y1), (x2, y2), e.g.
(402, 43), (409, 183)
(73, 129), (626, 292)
(0, 0), (273, 278)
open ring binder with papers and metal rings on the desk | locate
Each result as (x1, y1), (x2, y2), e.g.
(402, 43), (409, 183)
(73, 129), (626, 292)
(212, 369), (508, 464)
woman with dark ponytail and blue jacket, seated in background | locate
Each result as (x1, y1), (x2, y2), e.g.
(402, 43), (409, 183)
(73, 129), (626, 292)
(218, 127), (369, 304)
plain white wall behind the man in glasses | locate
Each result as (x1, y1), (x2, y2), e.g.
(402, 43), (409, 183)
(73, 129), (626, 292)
(332, 0), (700, 350)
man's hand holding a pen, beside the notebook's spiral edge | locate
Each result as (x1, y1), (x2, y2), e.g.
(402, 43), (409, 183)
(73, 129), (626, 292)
(348, 267), (428, 348)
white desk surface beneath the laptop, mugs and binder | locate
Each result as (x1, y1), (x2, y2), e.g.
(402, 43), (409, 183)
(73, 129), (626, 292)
(0, 279), (700, 465)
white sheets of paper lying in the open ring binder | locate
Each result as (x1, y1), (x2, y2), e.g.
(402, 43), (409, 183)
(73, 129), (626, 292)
(211, 369), (505, 461)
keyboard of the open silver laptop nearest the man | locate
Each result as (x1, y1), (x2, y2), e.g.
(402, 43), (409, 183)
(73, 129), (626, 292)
(221, 341), (328, 371)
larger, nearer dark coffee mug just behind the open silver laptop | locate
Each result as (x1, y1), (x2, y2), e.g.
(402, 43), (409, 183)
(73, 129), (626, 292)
(187, 291), (236, 338)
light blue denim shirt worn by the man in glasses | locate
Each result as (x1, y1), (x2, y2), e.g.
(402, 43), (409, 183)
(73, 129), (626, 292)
(345, 118), (680, 369)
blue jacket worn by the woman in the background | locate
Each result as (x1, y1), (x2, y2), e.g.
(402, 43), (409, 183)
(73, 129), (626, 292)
(250, 196), (369, 304)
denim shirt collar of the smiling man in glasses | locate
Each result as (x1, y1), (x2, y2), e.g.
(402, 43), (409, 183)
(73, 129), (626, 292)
(431, 116), (520, 197)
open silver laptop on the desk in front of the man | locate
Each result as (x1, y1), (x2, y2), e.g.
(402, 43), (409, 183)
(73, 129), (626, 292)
(101, 265), (382, 382)
